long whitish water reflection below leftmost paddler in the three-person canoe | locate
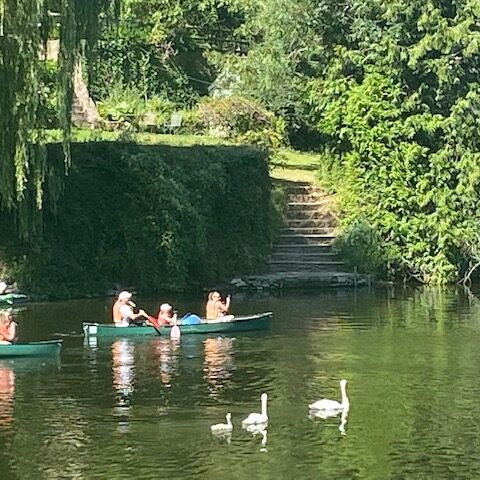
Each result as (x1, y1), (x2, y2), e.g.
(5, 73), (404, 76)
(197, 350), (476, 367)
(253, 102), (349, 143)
(112, 339), (135, 430)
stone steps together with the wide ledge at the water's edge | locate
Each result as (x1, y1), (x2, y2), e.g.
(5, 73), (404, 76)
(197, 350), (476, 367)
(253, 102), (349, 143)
(230, 182), (370, 292)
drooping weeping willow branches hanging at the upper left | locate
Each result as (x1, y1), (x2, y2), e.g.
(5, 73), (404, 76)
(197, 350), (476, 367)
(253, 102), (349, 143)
(0, 0), (120, 235)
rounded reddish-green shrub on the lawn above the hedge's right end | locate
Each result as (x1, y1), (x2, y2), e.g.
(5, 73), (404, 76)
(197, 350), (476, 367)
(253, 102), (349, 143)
(198, 96), (285, 149)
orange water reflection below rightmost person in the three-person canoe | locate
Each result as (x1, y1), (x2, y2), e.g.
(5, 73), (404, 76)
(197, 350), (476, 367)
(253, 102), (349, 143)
(203, 337), (234, 397)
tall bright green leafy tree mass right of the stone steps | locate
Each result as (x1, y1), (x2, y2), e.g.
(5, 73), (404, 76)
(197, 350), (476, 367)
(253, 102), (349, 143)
(306, 1), (480, 283)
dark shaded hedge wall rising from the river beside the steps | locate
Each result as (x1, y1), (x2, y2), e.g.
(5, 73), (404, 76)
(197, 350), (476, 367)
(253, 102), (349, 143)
(0, 142), (275, 297)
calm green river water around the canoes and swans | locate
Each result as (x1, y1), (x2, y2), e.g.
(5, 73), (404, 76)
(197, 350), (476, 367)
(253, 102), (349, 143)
(0, 288), (480, 480)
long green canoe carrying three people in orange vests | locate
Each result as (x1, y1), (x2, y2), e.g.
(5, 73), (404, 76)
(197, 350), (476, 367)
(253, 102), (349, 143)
(83, 312), (272, 337)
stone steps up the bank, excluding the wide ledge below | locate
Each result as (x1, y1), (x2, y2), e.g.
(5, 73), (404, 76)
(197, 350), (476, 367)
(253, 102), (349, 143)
(268, 183), (345, 273)
